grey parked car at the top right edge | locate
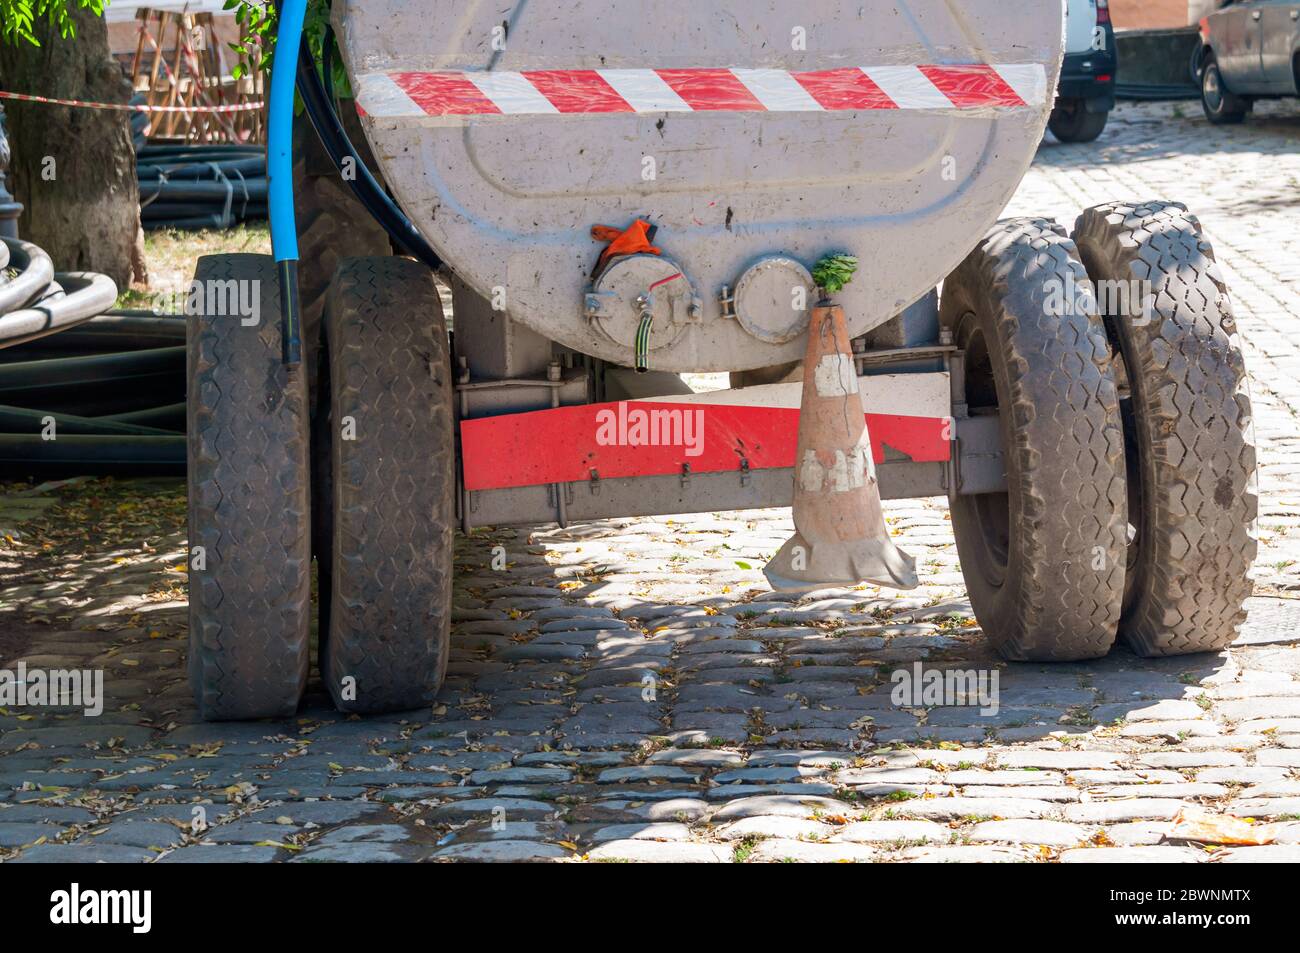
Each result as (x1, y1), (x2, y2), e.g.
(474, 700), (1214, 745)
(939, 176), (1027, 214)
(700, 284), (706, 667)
(1193, 0), (1300, 125)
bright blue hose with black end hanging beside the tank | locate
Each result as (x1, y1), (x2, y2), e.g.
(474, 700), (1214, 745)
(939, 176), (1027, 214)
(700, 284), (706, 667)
(267, 0), (307, 364)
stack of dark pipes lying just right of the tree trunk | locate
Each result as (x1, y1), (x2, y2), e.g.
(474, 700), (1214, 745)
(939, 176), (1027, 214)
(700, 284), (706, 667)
(135, 143), (267, 229)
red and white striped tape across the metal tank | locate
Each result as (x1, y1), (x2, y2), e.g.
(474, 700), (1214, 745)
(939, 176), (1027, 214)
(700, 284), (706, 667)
(358, 64), (1048, 118)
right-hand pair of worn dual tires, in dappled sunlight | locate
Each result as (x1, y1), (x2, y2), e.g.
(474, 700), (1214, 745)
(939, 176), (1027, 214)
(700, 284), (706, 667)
(943, 202), (1258, 660)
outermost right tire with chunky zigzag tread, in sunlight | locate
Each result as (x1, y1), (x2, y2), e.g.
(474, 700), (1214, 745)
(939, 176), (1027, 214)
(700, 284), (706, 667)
(1074, 202), (1258, 657)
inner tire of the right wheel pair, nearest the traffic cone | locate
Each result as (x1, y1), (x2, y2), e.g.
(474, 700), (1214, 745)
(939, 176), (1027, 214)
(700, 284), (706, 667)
(940, 218), (1127, 662)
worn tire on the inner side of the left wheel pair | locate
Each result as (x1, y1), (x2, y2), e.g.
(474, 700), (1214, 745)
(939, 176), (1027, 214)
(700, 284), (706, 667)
(321, 257), (456, 714)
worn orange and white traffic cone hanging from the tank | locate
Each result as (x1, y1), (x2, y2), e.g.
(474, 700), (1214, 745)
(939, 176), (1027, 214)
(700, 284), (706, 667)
(763, 303), (918, 592)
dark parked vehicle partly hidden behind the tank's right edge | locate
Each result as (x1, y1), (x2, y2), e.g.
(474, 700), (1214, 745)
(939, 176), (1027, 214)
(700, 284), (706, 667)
(1048, 0), (1117, 142)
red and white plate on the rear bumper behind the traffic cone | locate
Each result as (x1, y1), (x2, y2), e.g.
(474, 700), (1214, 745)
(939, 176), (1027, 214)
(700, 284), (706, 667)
(460, 373), (952, 490)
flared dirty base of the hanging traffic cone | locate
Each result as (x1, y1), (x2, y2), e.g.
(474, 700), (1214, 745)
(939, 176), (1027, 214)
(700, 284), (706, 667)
(763, 533), (920, 593)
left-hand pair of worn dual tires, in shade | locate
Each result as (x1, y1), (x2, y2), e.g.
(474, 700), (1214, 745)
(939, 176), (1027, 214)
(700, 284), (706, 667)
(189, 255), (455, 720)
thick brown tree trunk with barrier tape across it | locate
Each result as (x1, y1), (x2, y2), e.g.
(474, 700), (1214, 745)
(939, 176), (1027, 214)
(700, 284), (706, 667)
(0, 8), (146, 290)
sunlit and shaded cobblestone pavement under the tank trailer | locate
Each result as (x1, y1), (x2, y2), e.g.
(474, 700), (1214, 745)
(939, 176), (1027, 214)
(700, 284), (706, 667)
(0, 104), (1300, 863)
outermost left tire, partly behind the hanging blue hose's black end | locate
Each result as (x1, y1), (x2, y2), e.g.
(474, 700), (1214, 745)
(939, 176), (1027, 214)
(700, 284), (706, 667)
(187, 255), (311, 720)
